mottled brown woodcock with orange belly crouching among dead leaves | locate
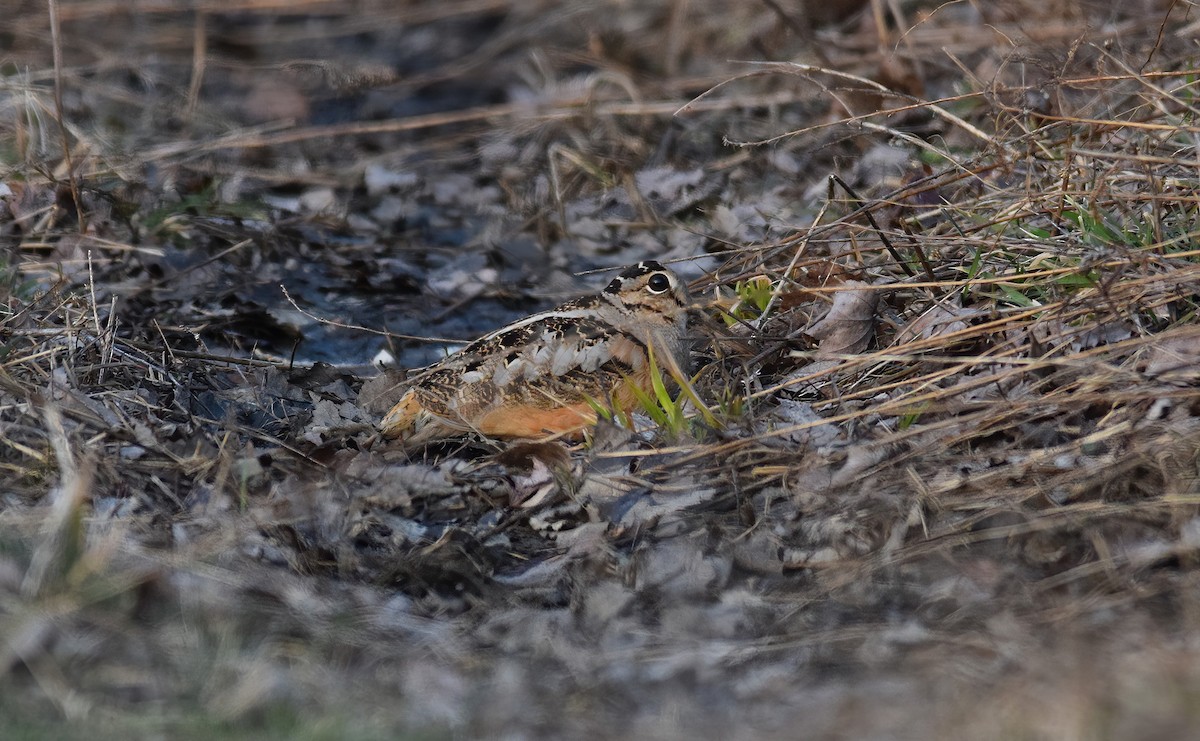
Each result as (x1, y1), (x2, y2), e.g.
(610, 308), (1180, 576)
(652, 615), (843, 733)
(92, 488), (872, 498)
(378, 260), (691, 447)
